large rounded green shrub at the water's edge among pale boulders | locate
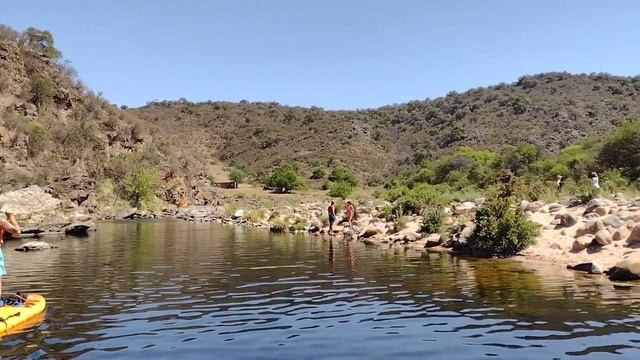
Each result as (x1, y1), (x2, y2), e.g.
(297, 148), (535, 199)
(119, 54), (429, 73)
(469, 197), (538, 256)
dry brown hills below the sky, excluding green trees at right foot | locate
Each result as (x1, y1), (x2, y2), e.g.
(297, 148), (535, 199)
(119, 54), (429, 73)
(0, 26), (640, 206)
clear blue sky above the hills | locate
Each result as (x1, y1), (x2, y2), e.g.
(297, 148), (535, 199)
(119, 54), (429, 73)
(0, 0), (640, 109)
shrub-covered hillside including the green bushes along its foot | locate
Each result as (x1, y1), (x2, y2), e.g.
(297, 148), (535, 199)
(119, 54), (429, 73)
(0, 26), (640, 213)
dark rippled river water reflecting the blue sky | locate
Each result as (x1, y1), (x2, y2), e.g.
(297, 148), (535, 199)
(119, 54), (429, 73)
(0, 222), (640, 359)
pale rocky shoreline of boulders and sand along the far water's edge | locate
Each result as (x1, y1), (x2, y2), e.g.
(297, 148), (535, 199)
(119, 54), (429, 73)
(8, 187), (640, 279)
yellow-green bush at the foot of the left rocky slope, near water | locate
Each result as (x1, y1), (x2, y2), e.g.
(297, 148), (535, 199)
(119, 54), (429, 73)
(121, 168), (159, 209)
